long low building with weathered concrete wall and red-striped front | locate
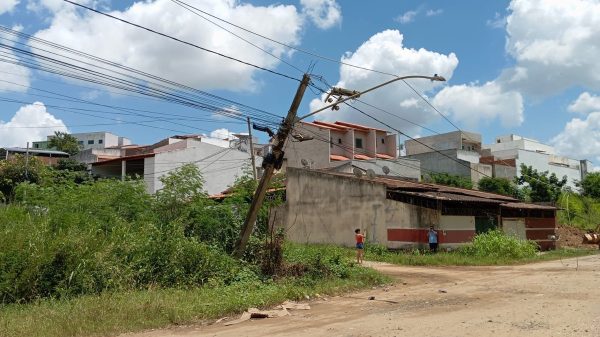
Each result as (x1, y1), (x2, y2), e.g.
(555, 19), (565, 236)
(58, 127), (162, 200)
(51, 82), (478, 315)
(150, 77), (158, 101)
(271, 168), (556, 249)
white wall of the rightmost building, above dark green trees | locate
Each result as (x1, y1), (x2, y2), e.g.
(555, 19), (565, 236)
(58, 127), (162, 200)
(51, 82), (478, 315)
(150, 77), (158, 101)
(516, 150), (581, 188)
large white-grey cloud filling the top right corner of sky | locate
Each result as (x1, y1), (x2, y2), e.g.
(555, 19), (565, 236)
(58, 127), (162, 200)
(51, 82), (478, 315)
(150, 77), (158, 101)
(500, 0), (600, 96)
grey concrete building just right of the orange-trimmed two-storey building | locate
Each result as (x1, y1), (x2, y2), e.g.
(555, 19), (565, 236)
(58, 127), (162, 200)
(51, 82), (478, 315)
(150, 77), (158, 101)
(405, 131), (493, 183)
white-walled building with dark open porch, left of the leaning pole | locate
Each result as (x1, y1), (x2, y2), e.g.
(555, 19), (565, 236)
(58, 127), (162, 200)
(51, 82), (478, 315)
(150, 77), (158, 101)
(91, 137), (262, 195)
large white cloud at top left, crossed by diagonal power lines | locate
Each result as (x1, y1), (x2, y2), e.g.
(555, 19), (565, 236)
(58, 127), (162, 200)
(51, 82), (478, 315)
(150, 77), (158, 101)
(36, 0), (303, 91)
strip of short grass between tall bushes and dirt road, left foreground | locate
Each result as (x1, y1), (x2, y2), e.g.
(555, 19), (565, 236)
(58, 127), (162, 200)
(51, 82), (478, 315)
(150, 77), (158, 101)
(0, 267), (389, 337)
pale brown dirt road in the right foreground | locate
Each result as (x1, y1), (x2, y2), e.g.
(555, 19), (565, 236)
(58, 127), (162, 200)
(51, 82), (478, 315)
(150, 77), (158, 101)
(127, 255), (600, 337)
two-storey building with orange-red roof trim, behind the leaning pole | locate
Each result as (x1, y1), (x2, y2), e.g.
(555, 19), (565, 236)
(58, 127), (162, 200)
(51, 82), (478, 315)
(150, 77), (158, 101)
(283, 121), (421, 180)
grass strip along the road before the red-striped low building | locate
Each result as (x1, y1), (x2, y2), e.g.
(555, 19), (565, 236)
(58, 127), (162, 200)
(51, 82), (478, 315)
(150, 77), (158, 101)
(365, 247), (598, 266)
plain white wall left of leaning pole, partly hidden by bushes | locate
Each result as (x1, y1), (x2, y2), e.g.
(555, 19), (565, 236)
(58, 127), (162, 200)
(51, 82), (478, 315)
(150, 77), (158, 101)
(144, 142), (261, 194)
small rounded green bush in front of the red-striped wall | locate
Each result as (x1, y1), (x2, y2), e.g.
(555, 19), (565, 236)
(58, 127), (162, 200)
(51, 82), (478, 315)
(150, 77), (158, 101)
(458, 230), (538, 259)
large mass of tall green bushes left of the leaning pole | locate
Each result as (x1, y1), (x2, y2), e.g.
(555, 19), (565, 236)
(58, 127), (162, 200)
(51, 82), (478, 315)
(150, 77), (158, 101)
(0, 180), (243, 303)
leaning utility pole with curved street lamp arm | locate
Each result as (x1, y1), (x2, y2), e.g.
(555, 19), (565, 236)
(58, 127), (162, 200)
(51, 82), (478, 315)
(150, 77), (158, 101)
(233, 74), (310, 258)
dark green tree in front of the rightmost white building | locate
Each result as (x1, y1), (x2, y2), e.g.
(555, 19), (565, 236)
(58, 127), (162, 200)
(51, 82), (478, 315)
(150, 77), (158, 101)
(516, 164), (567, 203)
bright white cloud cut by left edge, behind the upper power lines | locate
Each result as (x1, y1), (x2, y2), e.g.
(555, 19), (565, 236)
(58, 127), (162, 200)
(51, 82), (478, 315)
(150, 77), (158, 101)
(0, 25), (31, 92)
